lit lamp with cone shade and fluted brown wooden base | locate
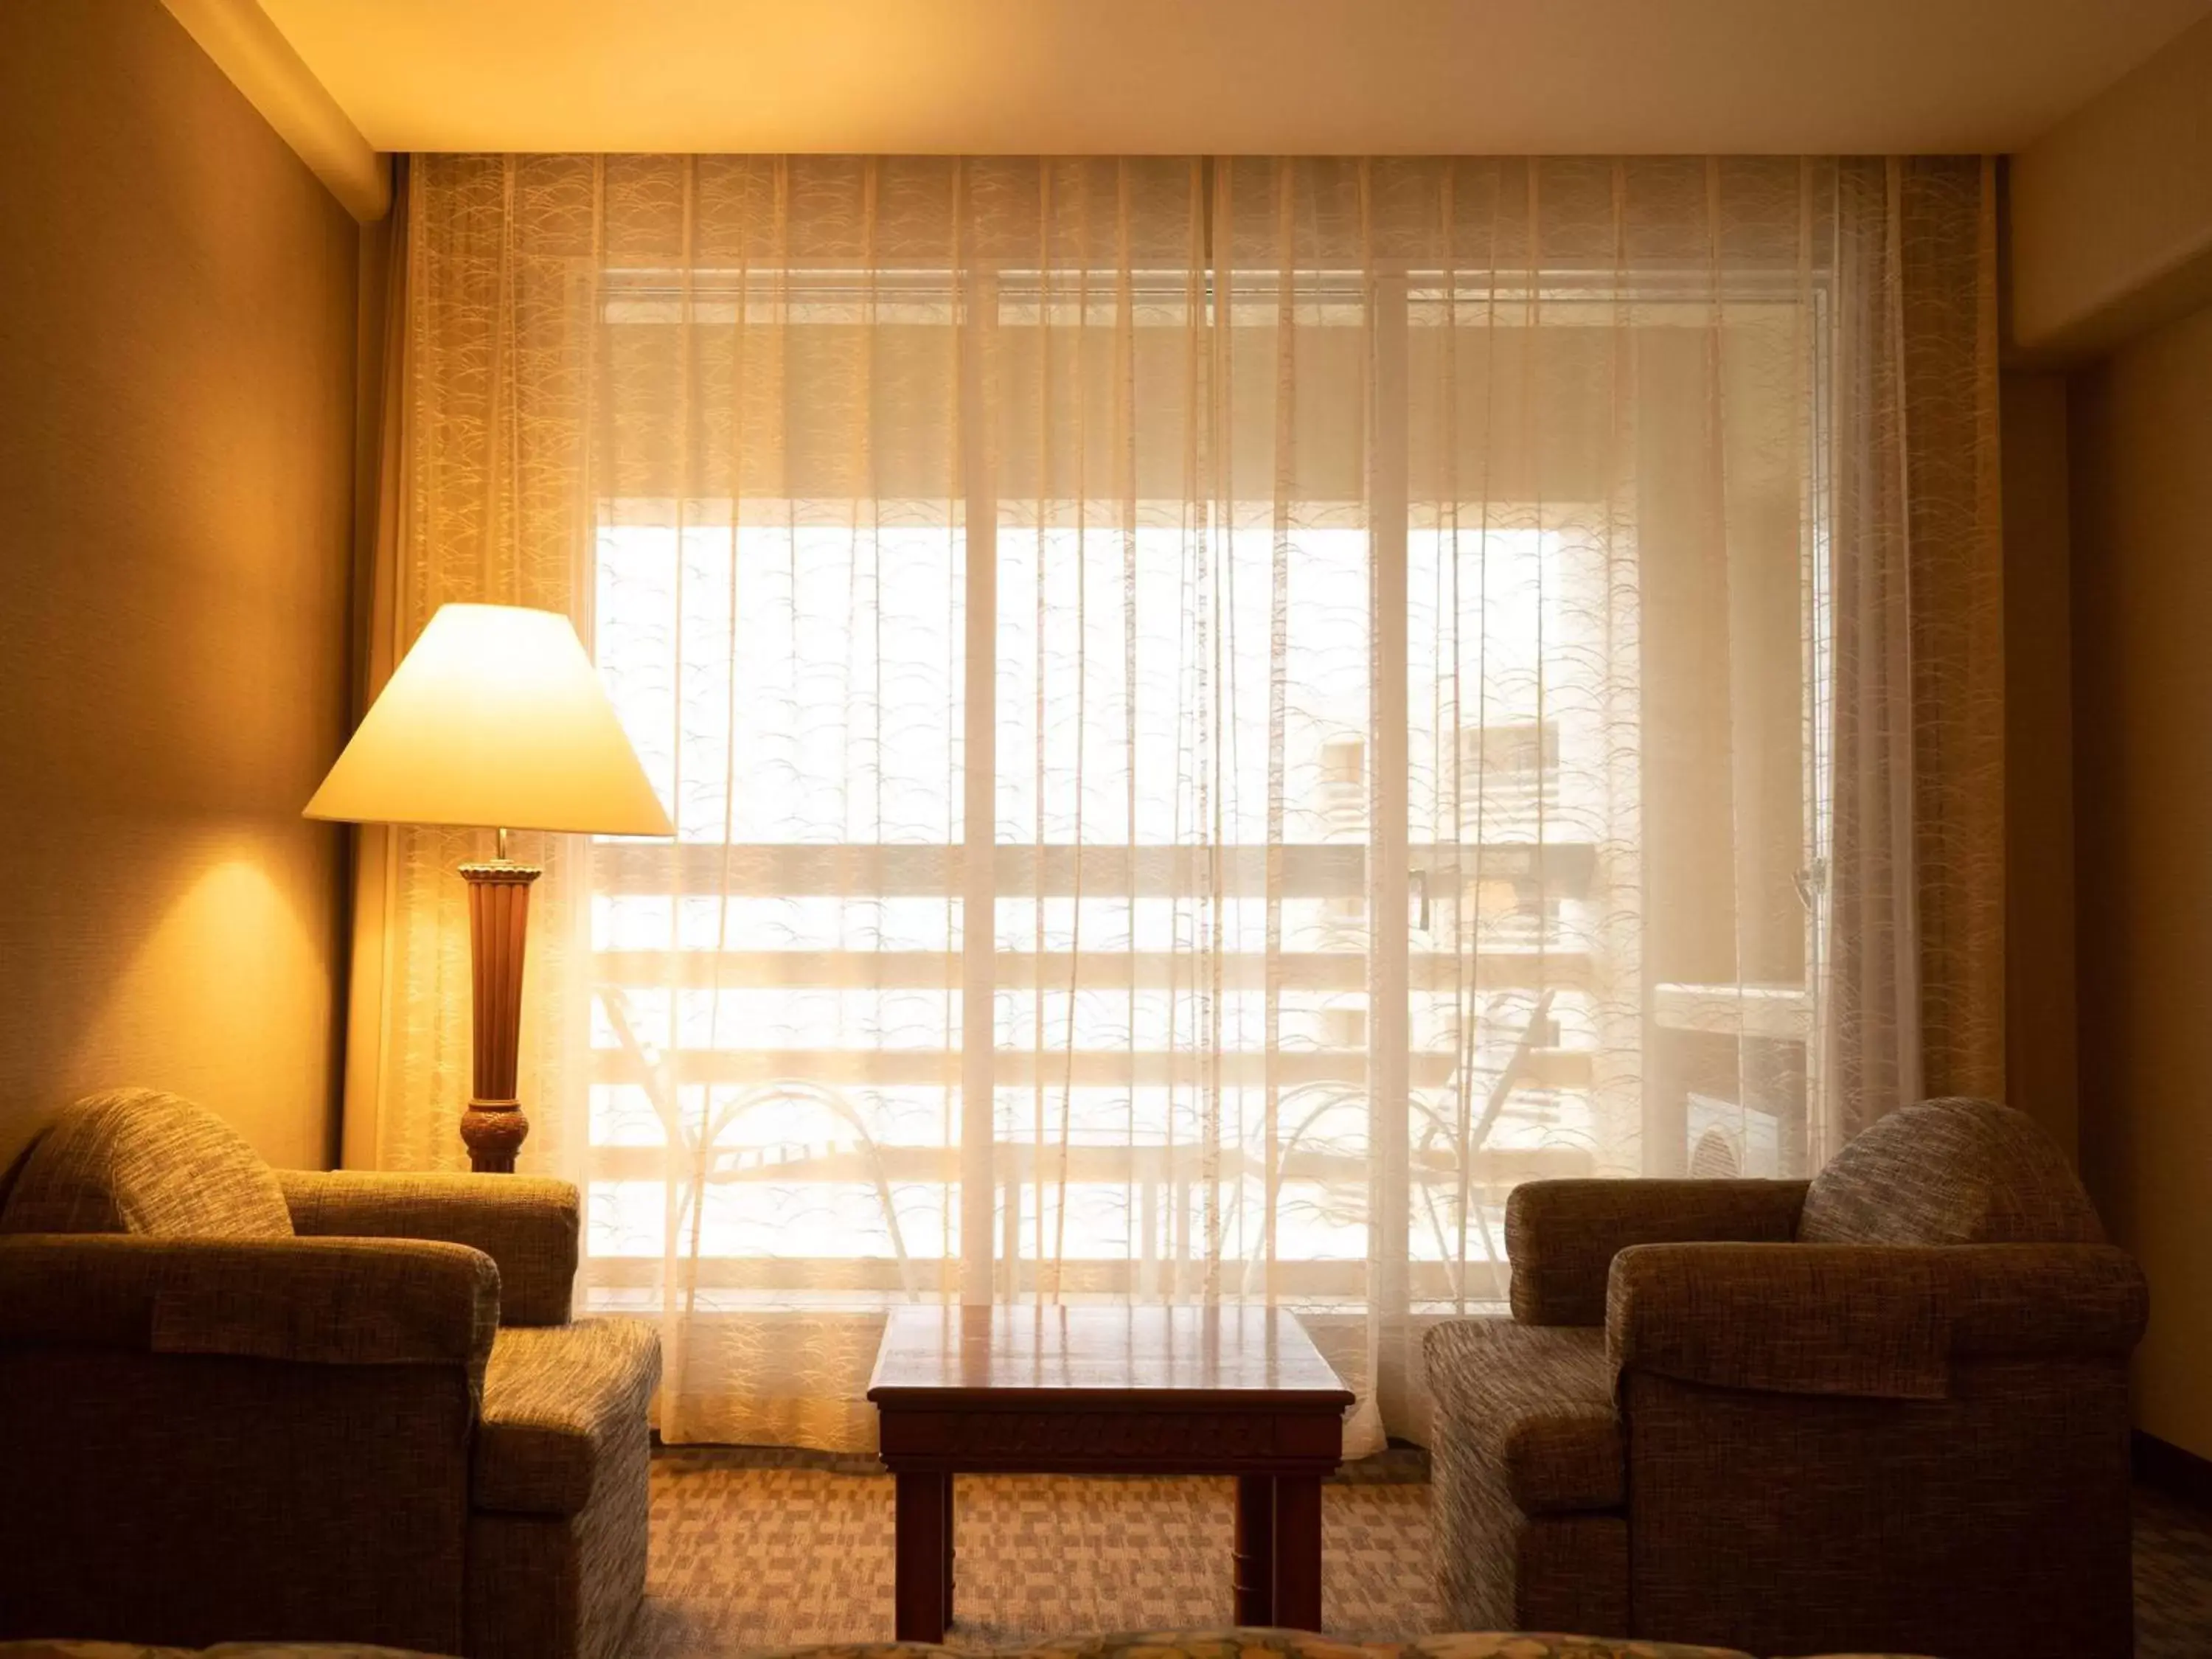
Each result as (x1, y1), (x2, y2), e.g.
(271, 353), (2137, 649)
(305, 604), (675, 1172)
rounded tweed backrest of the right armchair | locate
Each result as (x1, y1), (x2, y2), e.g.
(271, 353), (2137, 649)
(1796, 1099), (2104, 1245)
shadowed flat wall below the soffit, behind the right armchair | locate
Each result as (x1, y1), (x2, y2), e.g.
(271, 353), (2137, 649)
(2070, 310), (2212, 1458)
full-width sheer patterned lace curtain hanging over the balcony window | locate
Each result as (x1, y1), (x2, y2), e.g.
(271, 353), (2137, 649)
(349, 155), (2002, 1451)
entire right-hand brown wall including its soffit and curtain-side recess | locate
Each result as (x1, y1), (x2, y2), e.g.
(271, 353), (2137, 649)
(2004, 0), (2212, 1458)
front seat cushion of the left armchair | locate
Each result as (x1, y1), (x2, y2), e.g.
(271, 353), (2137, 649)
(469, 1318), (661, 1515)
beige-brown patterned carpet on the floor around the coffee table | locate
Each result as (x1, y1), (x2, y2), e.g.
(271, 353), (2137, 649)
(628, 1447), (2212, 1659)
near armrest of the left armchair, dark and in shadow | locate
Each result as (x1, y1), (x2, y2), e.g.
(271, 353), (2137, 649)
(0, 1234), (500, 1391)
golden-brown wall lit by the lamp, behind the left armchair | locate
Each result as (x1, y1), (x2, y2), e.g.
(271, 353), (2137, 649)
(0, 0), (356, 1166)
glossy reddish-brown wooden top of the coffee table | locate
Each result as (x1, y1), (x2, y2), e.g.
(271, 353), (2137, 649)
(867, 1307), (1352, 1411)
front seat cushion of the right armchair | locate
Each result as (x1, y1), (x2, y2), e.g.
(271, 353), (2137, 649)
(1425, 1318), (1628, 1515)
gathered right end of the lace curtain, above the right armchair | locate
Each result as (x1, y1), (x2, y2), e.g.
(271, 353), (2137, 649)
(1814, 157), (2004, 1157)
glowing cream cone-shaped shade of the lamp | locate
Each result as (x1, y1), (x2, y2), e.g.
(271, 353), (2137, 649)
(307, 604), (675, 836)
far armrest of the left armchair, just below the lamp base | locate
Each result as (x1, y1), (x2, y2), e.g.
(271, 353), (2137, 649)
(276, 1170), (580, 1325)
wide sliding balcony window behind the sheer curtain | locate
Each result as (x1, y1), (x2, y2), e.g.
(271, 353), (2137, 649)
(588, 265), (1823, 1312)
